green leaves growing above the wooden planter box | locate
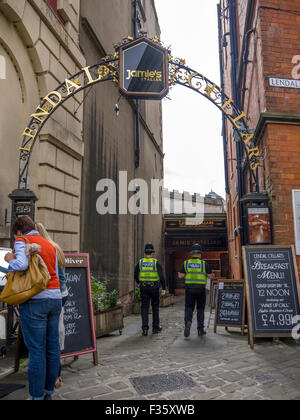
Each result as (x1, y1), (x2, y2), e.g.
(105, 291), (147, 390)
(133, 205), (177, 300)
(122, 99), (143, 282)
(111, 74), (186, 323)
(91, 274), (120, 313)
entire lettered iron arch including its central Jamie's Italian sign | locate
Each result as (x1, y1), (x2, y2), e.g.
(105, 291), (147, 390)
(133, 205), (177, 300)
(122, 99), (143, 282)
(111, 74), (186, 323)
(10, 37), (260, 221)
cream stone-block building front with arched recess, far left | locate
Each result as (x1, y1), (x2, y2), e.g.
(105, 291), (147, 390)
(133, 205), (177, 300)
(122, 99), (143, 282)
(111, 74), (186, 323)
(0, 0), (86, 252)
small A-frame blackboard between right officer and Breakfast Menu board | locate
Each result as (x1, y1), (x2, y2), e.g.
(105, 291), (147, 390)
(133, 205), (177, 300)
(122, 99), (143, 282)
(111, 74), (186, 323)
(214, 280), (246, 335)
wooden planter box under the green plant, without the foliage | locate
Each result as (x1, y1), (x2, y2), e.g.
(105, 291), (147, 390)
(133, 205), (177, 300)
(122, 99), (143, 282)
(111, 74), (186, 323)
(94, 306), (124, 338)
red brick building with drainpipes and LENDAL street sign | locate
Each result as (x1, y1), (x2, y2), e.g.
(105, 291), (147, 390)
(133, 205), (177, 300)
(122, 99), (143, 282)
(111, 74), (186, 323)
(219, 0), (300, 279)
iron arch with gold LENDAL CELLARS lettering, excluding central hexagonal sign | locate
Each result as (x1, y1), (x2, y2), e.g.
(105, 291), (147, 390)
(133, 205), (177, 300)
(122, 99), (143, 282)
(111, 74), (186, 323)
(18, 38), (259, 190)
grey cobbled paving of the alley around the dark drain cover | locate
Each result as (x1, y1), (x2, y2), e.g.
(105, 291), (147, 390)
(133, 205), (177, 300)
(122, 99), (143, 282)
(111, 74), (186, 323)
(2, 299), (300, 401)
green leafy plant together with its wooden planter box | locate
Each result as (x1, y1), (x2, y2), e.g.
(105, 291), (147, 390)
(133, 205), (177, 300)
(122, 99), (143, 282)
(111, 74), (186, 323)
(91, 275), (124, 338)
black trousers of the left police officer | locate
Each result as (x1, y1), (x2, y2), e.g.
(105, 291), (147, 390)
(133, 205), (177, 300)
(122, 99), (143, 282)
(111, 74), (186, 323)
(140, 284), (160, 330)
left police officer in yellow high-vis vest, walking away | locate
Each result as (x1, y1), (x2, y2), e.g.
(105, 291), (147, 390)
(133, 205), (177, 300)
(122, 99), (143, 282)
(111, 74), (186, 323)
(134, 242), (166, 336)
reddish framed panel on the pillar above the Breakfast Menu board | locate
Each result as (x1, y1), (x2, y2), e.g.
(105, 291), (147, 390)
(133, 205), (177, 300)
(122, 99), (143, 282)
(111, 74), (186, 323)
(247, 206), (272, 245)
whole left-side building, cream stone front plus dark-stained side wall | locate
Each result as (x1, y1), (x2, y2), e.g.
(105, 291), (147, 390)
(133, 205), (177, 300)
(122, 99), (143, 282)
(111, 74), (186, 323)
(0, 0), (163, 308)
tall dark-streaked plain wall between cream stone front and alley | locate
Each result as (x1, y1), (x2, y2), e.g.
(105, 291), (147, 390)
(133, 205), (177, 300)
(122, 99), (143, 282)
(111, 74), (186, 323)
(80, 0), (163, 301)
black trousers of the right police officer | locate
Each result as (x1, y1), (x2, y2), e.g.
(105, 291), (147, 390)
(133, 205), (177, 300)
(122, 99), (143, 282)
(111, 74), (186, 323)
(184, 287), (206, 330)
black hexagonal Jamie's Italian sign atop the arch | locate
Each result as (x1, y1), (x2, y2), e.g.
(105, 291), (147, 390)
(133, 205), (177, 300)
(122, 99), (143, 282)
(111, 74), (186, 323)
(119, 38), (169, 100)
